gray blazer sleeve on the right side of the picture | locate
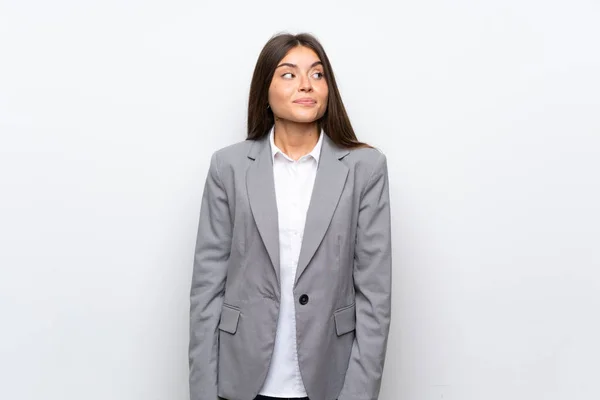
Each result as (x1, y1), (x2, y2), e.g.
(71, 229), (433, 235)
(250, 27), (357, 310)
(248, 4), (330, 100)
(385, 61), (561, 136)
(339, 153), (392, 400)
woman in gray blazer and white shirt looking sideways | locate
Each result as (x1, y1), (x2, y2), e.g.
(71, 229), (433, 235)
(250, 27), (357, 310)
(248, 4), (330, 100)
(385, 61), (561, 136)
(189, 34), (392, 400)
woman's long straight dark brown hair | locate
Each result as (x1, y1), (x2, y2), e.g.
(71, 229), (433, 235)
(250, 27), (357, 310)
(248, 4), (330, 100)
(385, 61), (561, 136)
(246, 33), (371, 148)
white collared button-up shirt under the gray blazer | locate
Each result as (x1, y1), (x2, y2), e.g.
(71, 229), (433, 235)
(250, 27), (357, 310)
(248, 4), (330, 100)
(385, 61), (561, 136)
(260, 128), (324, 397)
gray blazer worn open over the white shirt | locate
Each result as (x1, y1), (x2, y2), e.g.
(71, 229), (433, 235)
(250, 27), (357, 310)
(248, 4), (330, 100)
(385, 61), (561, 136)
(189, 135), (392, 400)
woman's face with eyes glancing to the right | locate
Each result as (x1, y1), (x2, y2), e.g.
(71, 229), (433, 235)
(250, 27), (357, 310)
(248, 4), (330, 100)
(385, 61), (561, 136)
(269, 46), (329, 123)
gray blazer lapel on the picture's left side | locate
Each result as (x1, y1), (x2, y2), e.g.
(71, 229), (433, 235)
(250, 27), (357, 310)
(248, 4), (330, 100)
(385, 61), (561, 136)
(246, 135), (279, 282)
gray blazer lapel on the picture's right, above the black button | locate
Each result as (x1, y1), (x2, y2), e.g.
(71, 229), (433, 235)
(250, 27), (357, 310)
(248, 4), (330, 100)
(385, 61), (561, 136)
(294, 135), (349, 285)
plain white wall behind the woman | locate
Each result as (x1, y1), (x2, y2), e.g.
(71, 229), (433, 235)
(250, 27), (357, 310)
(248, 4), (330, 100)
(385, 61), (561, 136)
(0, 0), (600, 400)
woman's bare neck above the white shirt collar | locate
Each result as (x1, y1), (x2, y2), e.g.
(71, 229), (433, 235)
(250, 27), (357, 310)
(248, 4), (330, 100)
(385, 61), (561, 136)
(273, 119), (321, 160)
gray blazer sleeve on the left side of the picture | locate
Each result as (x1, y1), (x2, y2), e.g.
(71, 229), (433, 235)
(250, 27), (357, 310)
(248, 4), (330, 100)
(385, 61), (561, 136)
(189, 153), (232, 400)
